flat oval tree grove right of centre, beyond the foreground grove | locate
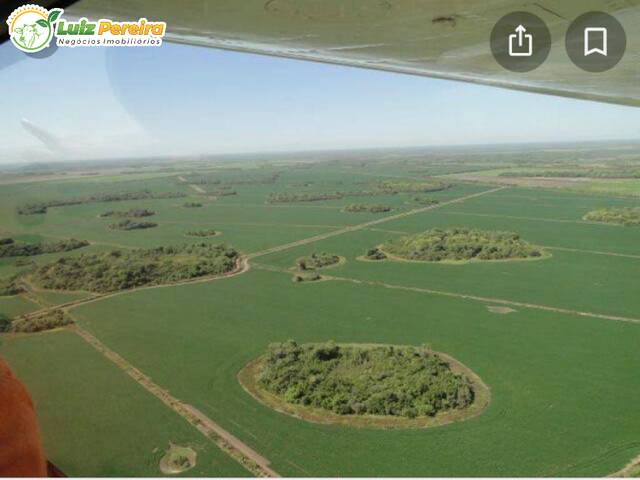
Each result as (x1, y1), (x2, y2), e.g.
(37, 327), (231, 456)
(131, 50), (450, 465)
(382, 228), (542, 262)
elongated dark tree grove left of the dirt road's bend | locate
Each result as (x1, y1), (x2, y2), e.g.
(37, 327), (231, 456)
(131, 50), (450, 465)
(31, 243), (238, 293)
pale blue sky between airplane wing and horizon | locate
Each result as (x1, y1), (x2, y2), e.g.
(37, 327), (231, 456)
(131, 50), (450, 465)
(0, 39), (640, 163)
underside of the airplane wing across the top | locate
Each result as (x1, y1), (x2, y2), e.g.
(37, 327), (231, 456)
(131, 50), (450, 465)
(3, 0), (640, 106)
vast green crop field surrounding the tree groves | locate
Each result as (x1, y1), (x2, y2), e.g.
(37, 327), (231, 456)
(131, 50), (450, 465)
(0, 153), (640, 477)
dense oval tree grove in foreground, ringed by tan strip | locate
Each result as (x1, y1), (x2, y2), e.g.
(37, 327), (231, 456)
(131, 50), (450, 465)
(257, 341), (474, 418)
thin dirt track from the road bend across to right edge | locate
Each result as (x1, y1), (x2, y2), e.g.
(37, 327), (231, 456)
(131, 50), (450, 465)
(253, 263), (640, 324)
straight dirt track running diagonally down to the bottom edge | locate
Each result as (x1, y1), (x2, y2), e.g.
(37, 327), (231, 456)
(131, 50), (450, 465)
(69, 323), (280, 477)
